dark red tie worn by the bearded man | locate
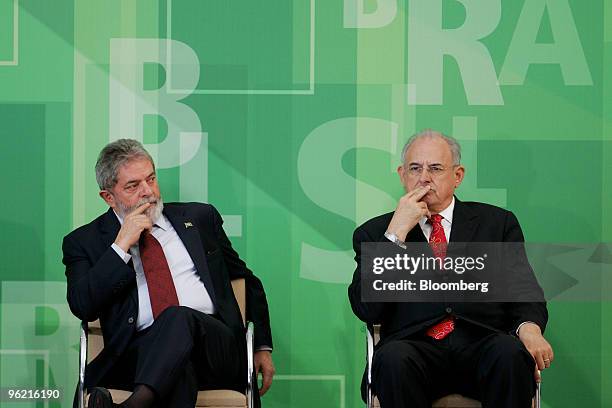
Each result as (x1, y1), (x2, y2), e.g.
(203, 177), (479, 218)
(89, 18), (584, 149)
(140, 231), (179, 319)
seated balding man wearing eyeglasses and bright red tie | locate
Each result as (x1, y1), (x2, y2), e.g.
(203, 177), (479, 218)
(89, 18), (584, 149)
(348, 130), (554, 408)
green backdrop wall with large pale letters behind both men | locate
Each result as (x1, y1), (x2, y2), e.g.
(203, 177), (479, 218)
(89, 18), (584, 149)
(0, 0), (612, 408)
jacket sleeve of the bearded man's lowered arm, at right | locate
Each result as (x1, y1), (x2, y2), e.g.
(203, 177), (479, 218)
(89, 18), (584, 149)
(211, 206), (273, 349)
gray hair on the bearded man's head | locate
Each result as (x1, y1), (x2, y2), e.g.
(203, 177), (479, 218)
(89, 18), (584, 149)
(96, 139), (155, 190)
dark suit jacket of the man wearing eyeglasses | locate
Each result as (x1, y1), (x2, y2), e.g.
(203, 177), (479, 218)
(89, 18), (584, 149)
(348, 198), (548, 345)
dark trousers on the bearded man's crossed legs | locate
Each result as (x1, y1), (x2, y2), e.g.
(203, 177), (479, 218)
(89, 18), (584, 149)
(99, 306), (246, 408)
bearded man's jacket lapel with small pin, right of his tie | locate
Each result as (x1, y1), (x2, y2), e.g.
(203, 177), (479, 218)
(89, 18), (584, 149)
(164, 206), (217, 305)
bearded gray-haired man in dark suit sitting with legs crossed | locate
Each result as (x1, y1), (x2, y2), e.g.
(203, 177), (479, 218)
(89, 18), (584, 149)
(63, 139), (274, 408)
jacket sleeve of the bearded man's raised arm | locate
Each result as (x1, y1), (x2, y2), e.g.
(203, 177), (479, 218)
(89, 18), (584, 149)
(62, 233), (136, 321)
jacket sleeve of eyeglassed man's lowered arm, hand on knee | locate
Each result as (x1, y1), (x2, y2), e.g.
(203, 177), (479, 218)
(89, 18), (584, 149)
(504, 212), (548, 334)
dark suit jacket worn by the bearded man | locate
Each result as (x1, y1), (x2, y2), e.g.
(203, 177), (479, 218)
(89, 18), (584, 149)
(62, 203), (272, 386)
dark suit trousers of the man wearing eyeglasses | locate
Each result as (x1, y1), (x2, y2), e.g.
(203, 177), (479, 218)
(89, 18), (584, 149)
(372, 320), (535, 408)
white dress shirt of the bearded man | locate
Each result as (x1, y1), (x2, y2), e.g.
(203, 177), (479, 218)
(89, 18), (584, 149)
(112, 213), (215, 330)
